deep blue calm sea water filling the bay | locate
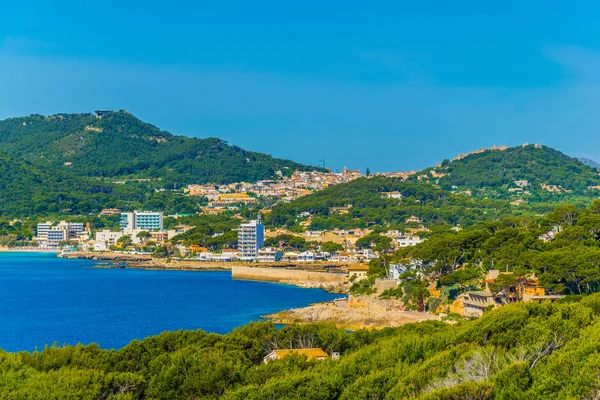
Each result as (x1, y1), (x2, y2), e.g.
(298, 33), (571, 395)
(0, 253), (337, 351)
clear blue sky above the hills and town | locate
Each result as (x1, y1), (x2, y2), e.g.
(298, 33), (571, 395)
(0, 0), (600, 171)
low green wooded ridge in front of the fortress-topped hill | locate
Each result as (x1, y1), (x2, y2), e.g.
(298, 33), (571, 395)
(265, 176), (553, 230)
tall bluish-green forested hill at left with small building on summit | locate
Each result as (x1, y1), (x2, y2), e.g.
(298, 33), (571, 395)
(0, 111), (324, 186)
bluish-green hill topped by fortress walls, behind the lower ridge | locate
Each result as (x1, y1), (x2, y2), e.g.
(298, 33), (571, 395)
(422, 145), (600, 191)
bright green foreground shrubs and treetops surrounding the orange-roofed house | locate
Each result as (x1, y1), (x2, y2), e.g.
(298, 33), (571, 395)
(0, 294), (600, 400)
